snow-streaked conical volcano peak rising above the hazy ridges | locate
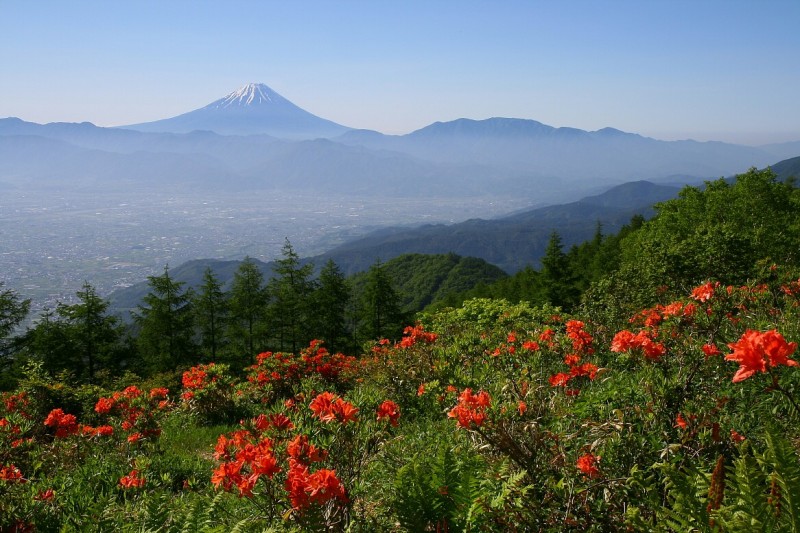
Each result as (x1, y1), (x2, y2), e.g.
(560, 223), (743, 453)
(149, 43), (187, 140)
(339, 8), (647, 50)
(120, 83), (350, 140)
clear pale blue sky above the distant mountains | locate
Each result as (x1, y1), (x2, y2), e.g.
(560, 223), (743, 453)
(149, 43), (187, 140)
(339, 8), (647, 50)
(0, 0), (800, 144)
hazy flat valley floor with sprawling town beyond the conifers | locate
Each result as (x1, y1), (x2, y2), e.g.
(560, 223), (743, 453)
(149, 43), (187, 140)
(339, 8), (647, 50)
(0, 190), (531, 316)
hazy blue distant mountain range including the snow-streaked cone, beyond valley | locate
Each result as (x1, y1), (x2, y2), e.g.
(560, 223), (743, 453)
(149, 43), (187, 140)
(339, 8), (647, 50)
(0, 84), (800, 205)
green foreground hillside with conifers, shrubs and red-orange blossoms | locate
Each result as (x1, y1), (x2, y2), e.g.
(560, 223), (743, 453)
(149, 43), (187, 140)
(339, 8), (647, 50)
(0, 169), (800, 532)
